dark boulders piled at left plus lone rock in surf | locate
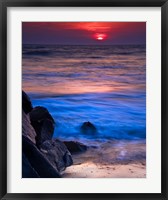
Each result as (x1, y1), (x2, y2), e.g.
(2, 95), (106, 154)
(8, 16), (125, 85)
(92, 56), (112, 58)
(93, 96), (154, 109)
(22, 91), (87, 178)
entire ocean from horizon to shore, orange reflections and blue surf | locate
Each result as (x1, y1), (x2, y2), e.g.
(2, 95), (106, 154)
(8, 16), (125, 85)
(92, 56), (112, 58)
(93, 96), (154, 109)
(22, 45), (146, 141)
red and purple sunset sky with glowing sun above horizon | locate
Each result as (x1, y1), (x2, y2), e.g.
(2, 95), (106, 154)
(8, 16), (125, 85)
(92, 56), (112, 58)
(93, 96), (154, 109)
(22, 22), (146, 45)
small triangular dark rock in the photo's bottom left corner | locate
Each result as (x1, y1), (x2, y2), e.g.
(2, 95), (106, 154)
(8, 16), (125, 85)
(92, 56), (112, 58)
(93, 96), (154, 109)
(22, 153), (40, 178)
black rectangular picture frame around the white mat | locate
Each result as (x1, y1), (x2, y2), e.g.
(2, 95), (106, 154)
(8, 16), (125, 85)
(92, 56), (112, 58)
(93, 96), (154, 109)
(0, 0), (168, 200)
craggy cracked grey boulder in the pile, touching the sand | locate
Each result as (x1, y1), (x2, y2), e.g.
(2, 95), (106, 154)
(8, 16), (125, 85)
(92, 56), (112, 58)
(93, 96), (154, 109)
(40, 139), (73, 172)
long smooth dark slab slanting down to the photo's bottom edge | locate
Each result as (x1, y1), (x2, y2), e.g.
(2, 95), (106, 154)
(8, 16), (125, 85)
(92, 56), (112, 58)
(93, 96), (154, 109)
(22, 136), (60, 178)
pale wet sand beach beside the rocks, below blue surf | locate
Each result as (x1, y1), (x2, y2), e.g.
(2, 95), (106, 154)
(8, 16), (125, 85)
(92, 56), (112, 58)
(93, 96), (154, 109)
(63, 141), (146, 178)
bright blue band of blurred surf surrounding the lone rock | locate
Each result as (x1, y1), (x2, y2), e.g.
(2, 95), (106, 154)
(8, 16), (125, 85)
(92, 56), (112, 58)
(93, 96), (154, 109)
(30, 90), (146, 140)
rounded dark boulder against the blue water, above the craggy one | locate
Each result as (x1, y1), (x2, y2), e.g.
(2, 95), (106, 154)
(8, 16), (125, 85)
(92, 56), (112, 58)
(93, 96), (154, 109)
(29, 106), (55, 147)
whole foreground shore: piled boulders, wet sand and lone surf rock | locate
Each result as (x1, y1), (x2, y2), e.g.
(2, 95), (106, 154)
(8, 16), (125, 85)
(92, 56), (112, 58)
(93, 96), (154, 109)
(22, 91), (146, 178)
